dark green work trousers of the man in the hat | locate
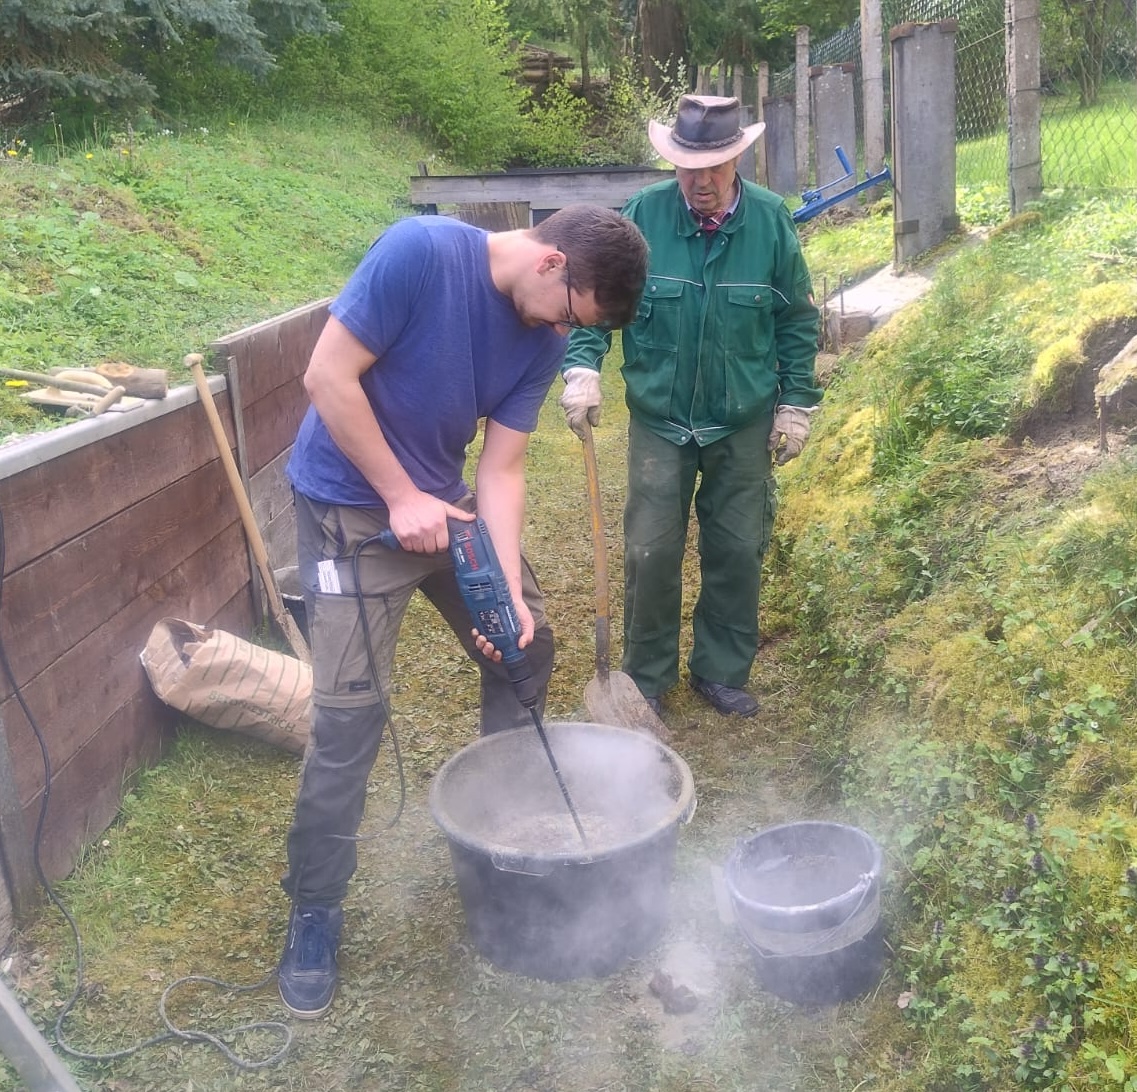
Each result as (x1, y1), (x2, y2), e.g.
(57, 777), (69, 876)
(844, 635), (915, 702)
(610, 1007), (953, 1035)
(623, 416), (777, 697)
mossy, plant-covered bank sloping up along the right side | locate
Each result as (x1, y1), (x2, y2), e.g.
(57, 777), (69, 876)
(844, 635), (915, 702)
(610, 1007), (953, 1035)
(763, 193), (1137, 1090)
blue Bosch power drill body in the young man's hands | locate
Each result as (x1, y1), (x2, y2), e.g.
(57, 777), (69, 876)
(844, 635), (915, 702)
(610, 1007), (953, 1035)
(380, 516), (538, 710)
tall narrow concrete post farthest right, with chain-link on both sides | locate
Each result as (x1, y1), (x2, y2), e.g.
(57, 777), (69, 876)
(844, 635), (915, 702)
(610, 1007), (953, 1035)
(1006, 0), (1043, 215)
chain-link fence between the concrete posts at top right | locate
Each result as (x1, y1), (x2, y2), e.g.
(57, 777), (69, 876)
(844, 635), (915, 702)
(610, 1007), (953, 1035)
(750, 0), (1137, 189)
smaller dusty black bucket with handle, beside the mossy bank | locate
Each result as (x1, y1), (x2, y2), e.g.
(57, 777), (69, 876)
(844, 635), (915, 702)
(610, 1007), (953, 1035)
(727, 821), (883, 1004)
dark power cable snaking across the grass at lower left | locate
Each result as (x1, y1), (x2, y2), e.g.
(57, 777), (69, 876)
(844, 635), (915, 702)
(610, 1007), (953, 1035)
(0, 511), (292, 1069)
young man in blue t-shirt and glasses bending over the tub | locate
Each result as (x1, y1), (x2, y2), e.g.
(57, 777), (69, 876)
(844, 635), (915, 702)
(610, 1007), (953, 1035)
(279, 205), (647, 1018)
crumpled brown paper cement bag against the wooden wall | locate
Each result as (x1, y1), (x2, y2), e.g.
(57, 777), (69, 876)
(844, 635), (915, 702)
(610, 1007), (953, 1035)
(140, 618), (312, 754)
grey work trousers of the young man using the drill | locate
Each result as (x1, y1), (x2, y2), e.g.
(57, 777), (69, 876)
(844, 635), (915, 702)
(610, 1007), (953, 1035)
(281, 494), (554, 905)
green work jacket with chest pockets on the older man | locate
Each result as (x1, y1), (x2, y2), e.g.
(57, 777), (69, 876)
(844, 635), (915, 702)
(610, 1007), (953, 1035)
(562, 180), (821, 445)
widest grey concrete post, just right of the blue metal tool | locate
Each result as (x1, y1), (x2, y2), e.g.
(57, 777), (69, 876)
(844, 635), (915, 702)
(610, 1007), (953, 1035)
(889, 19), (960, 268)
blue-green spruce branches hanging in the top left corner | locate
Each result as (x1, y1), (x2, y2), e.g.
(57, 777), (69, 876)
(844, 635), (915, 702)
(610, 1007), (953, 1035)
(0, 0), (335, 116)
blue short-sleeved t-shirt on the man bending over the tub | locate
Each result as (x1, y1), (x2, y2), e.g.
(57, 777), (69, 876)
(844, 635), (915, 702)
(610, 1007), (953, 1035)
(288, 216), (565, 507)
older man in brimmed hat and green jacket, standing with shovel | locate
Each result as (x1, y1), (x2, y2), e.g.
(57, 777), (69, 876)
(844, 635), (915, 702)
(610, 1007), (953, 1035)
(561, 96), (821, 717)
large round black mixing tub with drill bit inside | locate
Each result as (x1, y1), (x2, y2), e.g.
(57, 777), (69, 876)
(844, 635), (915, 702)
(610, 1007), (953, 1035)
(430, 722), (695, 982)
